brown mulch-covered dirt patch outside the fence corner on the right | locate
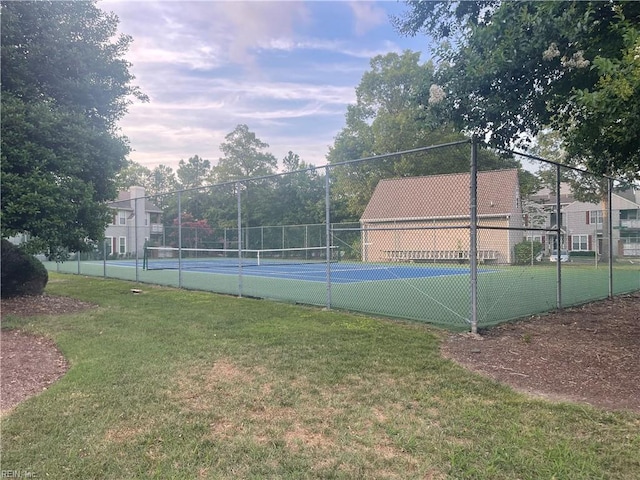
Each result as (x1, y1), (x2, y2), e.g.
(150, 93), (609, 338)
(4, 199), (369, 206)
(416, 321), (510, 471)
(442, 292), (640, 411)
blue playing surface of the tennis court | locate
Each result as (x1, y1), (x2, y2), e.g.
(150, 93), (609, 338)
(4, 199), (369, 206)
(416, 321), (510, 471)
(109, 261), (480, 283)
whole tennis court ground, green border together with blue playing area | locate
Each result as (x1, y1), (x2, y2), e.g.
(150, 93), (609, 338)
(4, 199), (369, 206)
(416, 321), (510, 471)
(47, 260), (640, 330)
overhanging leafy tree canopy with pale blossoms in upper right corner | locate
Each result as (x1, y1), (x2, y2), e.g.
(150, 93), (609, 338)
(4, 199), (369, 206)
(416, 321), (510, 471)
(395, 0), (640, 178)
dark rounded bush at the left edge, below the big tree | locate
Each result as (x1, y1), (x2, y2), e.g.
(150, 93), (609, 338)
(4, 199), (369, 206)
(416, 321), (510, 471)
(0, 238), (49, 298)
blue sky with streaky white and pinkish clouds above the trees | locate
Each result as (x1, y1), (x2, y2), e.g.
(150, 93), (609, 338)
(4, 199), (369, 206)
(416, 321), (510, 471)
(98, 0), (428, 170)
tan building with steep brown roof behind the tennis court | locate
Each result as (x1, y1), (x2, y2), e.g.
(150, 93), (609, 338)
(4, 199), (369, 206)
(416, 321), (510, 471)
(360, 169), (523, 263)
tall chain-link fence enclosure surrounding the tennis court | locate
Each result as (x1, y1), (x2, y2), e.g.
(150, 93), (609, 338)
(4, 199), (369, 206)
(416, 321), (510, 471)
(47, 141), (640, 332)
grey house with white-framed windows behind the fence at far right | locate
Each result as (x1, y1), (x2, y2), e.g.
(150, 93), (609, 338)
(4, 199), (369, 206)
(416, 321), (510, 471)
(525, 184), (640, 257)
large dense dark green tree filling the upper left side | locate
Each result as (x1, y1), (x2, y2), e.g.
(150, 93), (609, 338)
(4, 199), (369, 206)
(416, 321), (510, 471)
(0, 1), (146, 258)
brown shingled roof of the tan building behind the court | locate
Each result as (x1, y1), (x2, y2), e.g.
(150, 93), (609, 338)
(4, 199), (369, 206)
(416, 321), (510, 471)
(361, 169), (519, 221)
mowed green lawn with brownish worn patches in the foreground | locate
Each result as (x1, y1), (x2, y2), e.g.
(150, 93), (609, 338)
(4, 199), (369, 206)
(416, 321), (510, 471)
(1, 274), (640, 479)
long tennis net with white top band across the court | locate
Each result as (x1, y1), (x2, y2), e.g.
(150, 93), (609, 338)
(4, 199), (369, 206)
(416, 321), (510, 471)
(143, 247), (339, 270)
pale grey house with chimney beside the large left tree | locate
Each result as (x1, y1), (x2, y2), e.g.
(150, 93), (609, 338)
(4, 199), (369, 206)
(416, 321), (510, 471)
(104, 187), (164, 257)
